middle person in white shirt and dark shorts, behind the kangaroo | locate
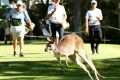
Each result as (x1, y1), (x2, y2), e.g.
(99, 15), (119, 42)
(45, 0), (67, 43)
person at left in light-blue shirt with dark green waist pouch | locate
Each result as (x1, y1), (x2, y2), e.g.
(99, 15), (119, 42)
(7, 1), (33, 57)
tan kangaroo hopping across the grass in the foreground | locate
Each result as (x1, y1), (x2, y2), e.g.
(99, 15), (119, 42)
(45, 33), (105, 80)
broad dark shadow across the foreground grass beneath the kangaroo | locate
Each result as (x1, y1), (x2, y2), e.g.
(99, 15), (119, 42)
(0, 58), (120, 80)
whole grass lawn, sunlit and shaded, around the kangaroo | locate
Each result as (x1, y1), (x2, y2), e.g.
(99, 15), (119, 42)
(0, 40), (120, 80)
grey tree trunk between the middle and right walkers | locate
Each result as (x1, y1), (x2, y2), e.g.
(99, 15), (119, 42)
(73, 0), (81, 32)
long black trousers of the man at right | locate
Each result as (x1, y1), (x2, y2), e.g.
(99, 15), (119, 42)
(89, 25), (102, 51)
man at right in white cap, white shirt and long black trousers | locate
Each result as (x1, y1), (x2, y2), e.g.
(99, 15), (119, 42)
(85, 0), (103, 54)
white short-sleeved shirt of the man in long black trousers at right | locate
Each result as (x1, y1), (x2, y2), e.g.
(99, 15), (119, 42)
(86, 8), (102, 26)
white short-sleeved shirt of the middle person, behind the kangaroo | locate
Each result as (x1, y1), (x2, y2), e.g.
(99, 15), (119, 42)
(48, 4), (66, 23)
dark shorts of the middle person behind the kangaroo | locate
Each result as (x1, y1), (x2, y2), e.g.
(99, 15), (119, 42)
(51, 23), (64, 38)
